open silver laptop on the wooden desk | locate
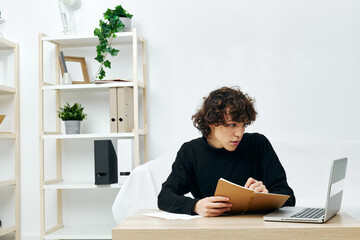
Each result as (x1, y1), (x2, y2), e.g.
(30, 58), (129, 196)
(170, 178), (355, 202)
(263, 158), (347, 223)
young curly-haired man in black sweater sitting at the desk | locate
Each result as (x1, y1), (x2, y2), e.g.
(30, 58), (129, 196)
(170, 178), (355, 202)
(158, 87), (295, 217)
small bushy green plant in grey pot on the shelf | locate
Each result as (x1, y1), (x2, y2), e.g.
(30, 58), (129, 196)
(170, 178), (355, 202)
(58, 102), (87, 134)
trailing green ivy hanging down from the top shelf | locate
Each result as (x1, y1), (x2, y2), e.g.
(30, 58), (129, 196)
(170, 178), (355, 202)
(92, 5), (133, 81)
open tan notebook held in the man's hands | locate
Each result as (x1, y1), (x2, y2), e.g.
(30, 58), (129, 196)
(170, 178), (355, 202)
(214, 178), (290, 213)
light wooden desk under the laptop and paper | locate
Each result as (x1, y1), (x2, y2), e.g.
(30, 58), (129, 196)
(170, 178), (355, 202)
(112, 210), (360, 240)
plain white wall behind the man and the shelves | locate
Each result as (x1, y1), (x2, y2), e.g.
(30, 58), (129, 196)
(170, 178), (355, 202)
(0, 0), (360, 239)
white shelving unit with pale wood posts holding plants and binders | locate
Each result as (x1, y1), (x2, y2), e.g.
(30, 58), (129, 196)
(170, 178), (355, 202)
(38, 29), (147, 239)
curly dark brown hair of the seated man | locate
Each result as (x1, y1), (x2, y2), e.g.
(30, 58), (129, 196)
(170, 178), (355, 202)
(191, 87), (257, 138)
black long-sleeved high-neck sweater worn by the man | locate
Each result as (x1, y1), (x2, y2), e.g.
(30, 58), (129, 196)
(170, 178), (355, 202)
(158, 133), (295, 214)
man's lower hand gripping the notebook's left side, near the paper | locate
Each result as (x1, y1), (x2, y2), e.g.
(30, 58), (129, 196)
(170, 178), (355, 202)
(194, 196), (232, 217)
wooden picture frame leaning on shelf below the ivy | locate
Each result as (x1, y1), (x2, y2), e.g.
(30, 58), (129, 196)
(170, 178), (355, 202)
(60, 56), (90, 84)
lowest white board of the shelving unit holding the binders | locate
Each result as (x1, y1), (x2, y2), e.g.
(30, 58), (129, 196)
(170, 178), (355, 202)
(44, 226), (114, 239)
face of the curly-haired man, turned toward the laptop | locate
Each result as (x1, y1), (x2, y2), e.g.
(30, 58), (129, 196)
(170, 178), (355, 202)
(207, 120), (245, 151)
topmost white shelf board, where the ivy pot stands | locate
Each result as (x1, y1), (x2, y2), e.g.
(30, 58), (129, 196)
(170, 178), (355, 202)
(42, 32), (143, 48)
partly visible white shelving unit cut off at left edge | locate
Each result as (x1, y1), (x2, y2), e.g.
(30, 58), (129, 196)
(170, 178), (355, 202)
(0, 37), (20, 240)
